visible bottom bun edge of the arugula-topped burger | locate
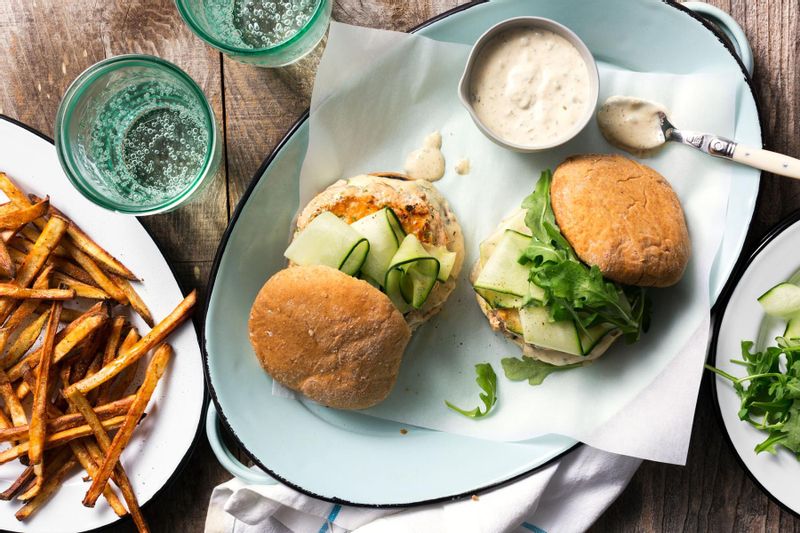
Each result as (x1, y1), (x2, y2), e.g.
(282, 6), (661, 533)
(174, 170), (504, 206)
(470, 209), (619, 366)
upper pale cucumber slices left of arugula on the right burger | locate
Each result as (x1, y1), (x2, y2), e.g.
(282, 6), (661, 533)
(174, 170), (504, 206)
(473, 230), (544, 308)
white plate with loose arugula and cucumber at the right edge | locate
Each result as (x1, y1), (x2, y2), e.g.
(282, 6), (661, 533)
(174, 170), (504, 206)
(709, 212), (800, 514)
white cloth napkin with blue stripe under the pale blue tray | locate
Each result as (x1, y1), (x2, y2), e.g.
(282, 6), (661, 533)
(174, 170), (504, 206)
(205, 446), (641, 533)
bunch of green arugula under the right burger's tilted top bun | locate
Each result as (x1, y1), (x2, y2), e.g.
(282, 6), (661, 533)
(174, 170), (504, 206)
(520, 170), (650, 342)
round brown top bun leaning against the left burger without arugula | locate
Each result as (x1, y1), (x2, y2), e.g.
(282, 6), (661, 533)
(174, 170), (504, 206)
(249, 266), (411, 409)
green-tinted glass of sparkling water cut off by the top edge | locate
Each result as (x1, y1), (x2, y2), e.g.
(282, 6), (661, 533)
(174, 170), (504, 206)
(175, 0), (331, 67)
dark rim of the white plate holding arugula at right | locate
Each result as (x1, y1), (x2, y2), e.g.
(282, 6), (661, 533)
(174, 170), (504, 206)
(703, 209), (800, 518)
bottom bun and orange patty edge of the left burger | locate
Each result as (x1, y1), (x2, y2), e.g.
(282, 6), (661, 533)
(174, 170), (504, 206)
(297, 172), (464, 329)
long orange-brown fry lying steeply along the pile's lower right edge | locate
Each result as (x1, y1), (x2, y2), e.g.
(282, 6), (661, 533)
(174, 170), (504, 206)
(83, 344), (172, 507)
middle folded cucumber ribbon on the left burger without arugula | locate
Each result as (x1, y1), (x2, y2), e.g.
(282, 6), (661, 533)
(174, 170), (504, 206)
(350, 207), (405, 282)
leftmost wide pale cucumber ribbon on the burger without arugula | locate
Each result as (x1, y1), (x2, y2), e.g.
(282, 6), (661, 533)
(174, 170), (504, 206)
(283, 211), (369, 276)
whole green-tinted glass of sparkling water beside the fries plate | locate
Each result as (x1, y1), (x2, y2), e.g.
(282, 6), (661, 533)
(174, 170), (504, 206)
(55, 55), (222, 215)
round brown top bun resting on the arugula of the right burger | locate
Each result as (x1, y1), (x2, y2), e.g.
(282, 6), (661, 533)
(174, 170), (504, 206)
(550, 154), (691, 287)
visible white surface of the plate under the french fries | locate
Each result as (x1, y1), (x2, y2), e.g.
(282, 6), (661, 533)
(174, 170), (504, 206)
(0, 115), (205, 532)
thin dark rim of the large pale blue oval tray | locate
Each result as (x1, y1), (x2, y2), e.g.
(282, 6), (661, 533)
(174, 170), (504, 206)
(200, 0), (763, 509)
